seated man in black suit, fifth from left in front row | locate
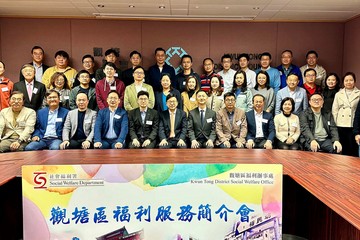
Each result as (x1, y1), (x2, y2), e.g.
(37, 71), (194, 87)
(128, 90), (159, 148)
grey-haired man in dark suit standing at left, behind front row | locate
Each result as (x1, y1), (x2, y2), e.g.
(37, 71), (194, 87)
(14, 64), (46, 111)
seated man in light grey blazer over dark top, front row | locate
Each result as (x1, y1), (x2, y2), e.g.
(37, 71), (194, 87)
(60, 92), (96, 149)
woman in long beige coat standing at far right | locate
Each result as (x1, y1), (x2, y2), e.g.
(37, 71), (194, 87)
(332, 72), (360, 156)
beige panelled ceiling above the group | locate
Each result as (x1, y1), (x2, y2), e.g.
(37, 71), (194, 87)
(0, 0), (360, 22)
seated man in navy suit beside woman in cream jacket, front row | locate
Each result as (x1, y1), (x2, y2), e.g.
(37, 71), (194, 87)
(246, 94), (275, 149)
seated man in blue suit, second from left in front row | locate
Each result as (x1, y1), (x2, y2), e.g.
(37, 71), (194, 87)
(25, 89), (69, 151)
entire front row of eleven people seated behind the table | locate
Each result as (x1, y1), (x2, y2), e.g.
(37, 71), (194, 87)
(0, 90), (342, 153)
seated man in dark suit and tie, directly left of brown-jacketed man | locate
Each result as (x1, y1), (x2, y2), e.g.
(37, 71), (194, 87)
(188, 90), (216, 148)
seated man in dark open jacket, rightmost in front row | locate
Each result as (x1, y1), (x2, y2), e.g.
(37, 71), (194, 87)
(299, 93), (342, 153)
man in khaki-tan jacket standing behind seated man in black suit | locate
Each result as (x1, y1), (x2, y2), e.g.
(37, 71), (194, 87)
(124, 66), (155, 111)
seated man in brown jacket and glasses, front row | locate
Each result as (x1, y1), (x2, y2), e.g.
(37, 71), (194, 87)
(216, 92), (247, 148)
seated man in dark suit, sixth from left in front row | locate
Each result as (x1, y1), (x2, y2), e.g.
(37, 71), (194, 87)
(159, 93), (187, 148)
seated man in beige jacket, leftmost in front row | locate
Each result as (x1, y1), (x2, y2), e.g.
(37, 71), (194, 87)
(0, 91), (36, 153)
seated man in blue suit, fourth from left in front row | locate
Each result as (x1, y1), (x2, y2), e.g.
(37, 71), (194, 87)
(94, 90), (128, 149)
